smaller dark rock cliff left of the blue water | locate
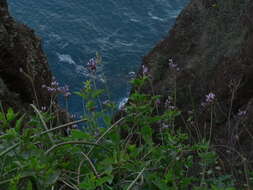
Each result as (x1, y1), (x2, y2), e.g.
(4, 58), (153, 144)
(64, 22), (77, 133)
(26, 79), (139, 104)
(0, 0), (52, 110)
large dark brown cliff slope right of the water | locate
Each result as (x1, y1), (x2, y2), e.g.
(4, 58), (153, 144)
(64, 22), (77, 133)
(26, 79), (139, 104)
(140, 0), (253, 181)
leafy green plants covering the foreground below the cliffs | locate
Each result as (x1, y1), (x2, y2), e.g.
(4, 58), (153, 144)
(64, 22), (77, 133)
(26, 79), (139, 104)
(0, 77), (242, 190)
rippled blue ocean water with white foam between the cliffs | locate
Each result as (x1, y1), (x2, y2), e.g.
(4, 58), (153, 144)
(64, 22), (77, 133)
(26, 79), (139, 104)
(8, 0), (188, 114)
